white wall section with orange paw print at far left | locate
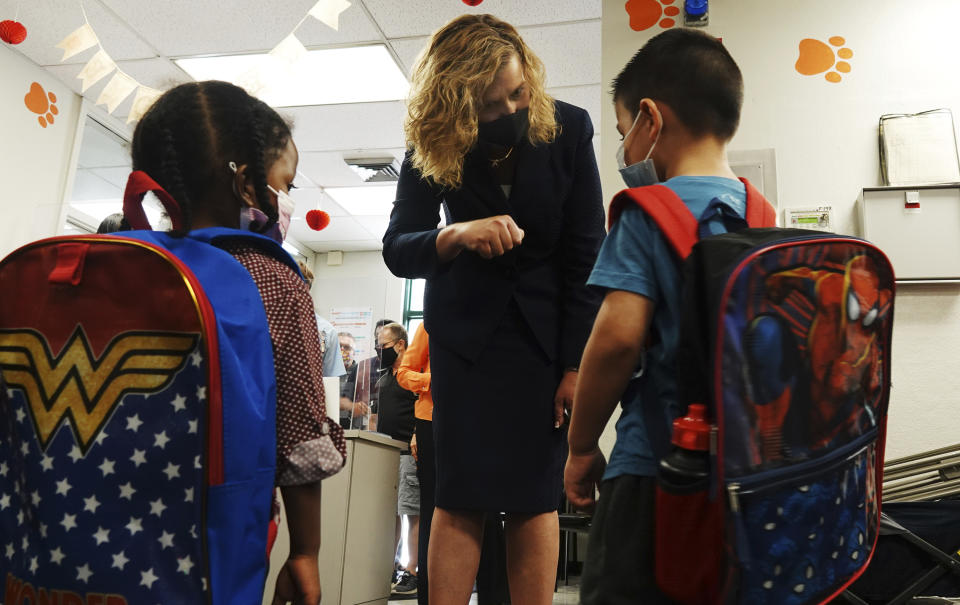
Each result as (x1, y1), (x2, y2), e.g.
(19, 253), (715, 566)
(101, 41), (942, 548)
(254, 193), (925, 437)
(0, 44), (81, 258)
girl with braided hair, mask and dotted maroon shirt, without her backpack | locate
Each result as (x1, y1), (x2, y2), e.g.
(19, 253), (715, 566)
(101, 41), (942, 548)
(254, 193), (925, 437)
(128, 81), (343, 605)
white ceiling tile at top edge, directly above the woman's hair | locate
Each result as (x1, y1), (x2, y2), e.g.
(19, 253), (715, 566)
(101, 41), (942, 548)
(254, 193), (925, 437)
(363, 0), (601, 38)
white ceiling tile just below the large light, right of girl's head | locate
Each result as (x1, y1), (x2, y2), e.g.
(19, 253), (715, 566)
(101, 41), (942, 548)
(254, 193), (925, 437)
(280, 101), (406, 152)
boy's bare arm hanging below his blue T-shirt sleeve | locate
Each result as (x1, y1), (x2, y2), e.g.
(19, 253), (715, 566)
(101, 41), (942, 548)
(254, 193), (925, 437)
(564, 290), (654, 510)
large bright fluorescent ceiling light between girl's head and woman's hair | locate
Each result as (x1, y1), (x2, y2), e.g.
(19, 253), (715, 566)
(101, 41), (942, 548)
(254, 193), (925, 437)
(176, 44), (410, 107)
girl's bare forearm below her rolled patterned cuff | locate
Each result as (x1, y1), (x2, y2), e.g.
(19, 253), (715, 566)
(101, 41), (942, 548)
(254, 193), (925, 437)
(273, 481), (321, 605)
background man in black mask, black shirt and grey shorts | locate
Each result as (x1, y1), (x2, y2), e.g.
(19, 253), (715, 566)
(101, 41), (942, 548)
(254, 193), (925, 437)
(370, 323), (420, 598)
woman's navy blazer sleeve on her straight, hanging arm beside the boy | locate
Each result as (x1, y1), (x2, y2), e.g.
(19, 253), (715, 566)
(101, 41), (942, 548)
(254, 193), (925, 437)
(560, 111), (605, 368)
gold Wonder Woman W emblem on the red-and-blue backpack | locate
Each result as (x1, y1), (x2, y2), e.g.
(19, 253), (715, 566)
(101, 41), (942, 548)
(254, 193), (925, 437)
(0, 325), (199, 453)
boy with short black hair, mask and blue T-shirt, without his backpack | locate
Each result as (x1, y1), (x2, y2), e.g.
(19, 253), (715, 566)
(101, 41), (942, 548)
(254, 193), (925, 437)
(564, 29), (746, 605)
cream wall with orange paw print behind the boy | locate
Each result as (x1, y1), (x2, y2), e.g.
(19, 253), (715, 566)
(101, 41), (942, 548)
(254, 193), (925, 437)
(600, 0), (960, 459)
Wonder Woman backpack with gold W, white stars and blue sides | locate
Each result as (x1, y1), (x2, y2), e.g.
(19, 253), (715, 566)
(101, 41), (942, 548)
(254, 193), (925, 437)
(0, 228), (297, 605)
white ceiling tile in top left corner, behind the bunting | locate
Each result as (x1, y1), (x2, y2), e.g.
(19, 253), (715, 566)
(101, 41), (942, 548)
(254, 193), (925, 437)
(9, 0), (157, 65)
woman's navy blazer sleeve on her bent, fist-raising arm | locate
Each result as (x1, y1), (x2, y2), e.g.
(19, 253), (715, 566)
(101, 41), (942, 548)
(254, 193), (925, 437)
(383, 151), (442, 278)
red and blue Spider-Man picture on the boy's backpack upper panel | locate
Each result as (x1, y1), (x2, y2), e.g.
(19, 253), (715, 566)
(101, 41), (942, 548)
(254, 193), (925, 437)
(744, 255), (892, 461)
